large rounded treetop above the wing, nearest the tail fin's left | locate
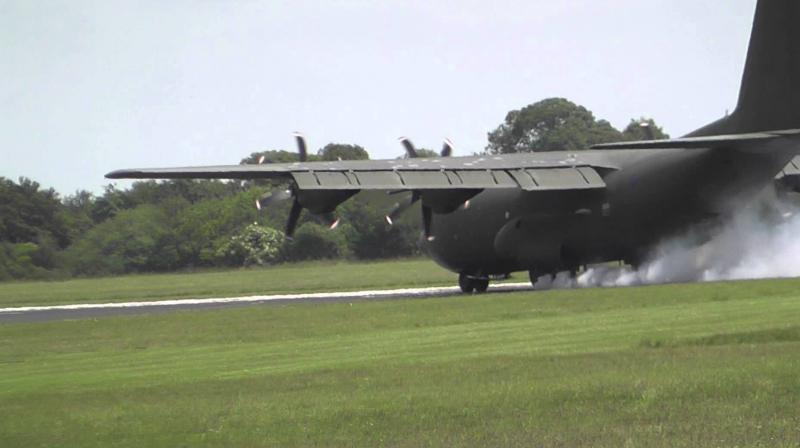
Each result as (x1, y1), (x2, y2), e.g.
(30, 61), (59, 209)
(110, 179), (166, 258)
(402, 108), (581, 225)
(486, 98), (622, 154)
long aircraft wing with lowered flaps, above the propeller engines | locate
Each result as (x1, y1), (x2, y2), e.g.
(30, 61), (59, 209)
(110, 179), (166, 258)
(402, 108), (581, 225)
(106, 153), (617, 191)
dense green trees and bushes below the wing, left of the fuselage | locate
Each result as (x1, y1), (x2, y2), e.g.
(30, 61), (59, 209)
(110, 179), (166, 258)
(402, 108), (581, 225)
(0, 178), (418, 280)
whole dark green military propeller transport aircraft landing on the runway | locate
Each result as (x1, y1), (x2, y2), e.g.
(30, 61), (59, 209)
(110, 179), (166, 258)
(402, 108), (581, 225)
(106, 0), (800, 292)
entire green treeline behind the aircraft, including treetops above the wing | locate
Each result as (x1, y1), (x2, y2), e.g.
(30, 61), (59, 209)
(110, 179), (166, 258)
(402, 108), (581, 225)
(0, 99), (666, 280)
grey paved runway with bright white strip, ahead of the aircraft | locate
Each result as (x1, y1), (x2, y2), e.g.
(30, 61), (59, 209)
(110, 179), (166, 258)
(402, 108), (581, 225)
(0, 283), (532, 324)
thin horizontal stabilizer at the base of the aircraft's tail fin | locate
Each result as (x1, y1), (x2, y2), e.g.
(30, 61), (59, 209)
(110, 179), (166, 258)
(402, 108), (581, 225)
(592, 129), (800, 149)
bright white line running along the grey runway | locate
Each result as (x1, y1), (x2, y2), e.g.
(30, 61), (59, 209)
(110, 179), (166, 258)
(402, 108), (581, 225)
(0, 283), (531, 314)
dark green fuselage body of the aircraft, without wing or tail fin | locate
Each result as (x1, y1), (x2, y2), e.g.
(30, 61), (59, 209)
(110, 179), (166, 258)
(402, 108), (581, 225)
(424, 145), (796, 276)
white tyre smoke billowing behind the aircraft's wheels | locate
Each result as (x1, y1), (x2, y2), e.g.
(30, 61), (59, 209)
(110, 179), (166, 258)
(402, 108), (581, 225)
(536, 194), (800, 289)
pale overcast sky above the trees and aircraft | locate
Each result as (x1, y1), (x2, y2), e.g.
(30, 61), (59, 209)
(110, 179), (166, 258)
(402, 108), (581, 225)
(0, 0), (756, 193)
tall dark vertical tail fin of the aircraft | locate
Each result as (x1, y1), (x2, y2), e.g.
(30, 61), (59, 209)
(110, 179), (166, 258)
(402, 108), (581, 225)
(689, 0), (800, 137)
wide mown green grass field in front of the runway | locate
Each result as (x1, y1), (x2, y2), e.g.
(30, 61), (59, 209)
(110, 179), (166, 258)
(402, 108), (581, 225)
(0, 280), (800, 447)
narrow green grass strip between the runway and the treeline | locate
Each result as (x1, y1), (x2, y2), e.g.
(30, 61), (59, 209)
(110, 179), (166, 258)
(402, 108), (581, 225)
(0, 259), (457, 308)
